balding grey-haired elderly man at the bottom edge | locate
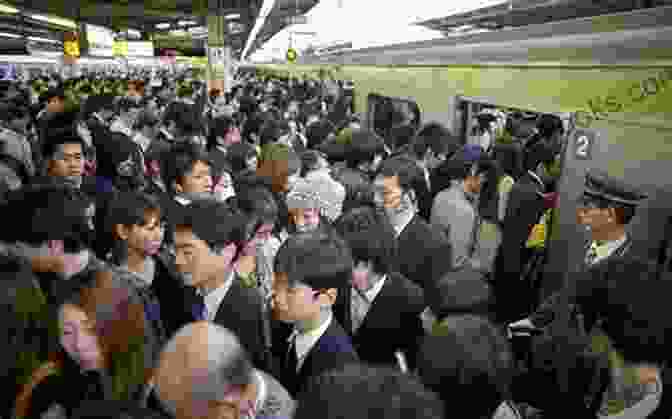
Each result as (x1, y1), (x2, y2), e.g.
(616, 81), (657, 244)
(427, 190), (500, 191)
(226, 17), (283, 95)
(155, 322), (294, 419)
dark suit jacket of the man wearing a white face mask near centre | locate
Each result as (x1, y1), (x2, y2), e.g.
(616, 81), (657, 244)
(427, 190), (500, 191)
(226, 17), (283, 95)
(396, 215), (453, 289)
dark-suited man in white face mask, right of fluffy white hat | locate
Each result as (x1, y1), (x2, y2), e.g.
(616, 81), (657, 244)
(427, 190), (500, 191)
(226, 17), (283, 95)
(374, 157), (452, 289)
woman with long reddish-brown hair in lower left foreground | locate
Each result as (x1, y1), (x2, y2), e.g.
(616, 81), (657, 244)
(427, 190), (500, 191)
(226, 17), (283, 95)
(14, 271), (151, 418)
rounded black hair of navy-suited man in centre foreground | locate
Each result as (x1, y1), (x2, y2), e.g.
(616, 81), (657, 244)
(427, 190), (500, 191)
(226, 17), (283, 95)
(274, 229), (353, 289)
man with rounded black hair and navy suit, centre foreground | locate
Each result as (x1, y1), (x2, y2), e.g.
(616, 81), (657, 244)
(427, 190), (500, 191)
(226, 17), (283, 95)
(273, 231), (358, 396)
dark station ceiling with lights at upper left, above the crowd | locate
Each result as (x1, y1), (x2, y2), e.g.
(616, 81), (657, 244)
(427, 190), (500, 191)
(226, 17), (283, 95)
(0, 0), (319, 58)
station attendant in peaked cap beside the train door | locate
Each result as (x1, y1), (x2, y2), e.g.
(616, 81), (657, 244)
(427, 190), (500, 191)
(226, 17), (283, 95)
(510, 170), (646, 334)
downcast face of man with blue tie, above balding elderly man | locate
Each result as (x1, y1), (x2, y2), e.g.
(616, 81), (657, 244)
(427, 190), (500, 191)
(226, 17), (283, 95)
(174, 227), (237, 287)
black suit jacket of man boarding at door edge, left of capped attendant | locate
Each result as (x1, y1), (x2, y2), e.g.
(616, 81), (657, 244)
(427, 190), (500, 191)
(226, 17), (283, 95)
(496, 172), (544, 282)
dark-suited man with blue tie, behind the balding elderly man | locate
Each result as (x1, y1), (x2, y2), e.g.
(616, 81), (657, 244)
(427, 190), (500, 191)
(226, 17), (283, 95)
(174, 201), (268, 369)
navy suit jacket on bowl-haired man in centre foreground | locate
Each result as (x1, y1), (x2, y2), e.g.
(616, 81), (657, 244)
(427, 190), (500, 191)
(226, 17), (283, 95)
(280, 317), (359, 399)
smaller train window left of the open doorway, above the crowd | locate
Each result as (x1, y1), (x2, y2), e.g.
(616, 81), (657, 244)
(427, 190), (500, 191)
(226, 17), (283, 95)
(368, 94), (421, 150)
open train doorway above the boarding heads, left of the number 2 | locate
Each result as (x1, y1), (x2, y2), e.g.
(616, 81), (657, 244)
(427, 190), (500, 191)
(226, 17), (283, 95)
(453, 97), (571, 150)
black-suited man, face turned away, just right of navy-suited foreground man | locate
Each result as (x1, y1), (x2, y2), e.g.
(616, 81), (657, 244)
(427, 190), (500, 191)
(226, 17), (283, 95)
(335, 207), (425, 369)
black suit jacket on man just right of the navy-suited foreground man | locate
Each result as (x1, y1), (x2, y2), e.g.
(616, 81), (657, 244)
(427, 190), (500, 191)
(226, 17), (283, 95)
(343, 273), (426, 369)
